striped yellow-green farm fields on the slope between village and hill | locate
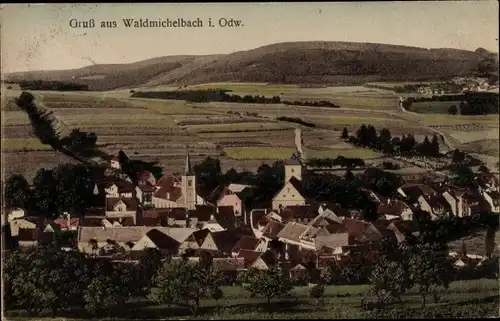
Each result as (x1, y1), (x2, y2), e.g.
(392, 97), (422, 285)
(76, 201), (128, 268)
(2, 83), (498, 181)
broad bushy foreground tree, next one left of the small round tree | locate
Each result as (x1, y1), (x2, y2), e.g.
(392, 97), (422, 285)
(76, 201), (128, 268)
(156, 260), (222, 315)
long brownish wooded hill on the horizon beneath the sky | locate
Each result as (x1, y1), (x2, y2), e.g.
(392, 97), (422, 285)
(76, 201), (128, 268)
(5, 41), (498, 90)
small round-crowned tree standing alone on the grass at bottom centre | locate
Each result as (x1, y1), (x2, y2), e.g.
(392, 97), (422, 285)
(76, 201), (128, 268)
(244, 266), (293, 306)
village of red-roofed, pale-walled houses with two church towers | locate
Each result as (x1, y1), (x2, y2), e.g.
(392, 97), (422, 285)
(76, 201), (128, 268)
(2, 125), (500, 274)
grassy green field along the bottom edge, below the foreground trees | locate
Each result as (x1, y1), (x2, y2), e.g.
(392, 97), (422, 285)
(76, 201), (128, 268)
(7, 280), (499, 321)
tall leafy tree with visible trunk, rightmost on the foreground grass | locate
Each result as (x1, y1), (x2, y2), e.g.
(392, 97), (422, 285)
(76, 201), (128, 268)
(408, 242), (453, 308)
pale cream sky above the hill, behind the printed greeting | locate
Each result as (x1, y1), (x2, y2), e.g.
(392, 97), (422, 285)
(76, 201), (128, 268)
(0, 0), (499, 73)
